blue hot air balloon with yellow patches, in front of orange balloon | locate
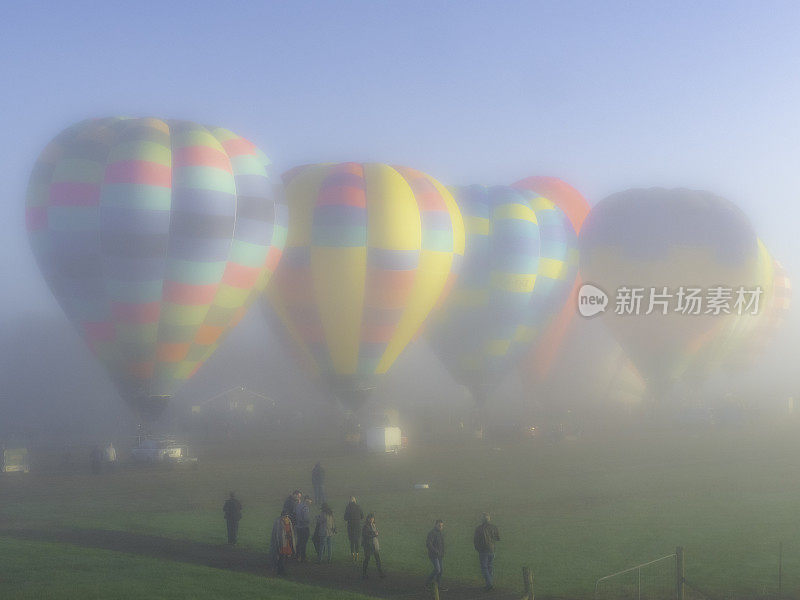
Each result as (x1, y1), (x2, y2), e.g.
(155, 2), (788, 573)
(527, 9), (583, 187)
(427, 185), (577, 406)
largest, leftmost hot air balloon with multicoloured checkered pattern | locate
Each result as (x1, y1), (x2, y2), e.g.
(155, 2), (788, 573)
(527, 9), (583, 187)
(26, 118), (286, 420)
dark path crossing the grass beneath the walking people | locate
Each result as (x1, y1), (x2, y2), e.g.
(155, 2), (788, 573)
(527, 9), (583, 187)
(0, 528), (522, 600)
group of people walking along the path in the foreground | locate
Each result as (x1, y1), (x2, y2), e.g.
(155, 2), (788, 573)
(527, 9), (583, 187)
(222, 463), (500, 591)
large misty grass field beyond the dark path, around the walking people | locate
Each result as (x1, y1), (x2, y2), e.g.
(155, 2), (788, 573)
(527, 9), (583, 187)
(0, 423), (800, 598)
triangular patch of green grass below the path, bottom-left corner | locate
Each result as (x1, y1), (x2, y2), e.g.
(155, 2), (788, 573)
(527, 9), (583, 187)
(0, 537), (376, 600)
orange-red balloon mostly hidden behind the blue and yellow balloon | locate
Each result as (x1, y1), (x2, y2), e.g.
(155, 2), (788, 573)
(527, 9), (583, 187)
(511, 176), (590, 385)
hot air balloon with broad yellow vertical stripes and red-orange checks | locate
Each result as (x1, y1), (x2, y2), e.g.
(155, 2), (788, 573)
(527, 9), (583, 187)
(266, 163), (464, 410)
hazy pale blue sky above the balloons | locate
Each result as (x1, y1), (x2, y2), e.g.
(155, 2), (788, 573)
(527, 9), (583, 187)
(0, 0), (800, 318)
